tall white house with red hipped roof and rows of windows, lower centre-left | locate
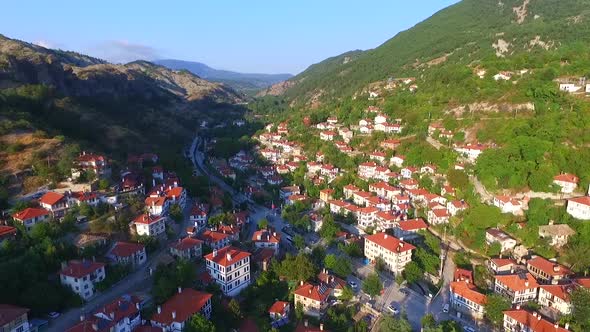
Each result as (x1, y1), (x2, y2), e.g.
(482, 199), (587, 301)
(205, 246), (251, 296)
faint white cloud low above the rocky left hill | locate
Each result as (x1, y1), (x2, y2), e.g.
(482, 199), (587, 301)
(88, 40), (160, 63)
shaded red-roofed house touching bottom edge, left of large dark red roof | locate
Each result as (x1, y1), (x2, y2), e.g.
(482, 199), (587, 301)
(66, 295), (141, 332)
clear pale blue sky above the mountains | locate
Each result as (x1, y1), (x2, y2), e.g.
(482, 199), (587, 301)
(0, 0), (458, 74)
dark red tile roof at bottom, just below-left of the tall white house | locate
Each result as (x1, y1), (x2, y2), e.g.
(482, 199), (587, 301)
(151, 288), (211, 326)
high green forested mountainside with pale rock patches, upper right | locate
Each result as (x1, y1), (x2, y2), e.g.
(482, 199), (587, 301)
(284, 0), (590, 102)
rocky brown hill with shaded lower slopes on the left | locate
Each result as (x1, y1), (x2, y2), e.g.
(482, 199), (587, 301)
(0, 35), (248, 170)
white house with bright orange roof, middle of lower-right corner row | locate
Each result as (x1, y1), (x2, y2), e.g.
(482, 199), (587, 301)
(494, 272), (539, 304)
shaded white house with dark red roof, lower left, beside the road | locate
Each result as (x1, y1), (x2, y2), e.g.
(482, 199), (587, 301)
(59, 260), (106, 300)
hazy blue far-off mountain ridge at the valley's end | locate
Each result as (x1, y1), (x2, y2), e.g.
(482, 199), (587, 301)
(154, 59), (293, 92)
